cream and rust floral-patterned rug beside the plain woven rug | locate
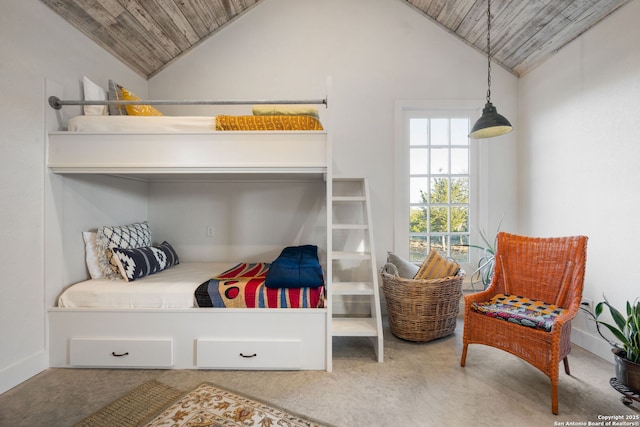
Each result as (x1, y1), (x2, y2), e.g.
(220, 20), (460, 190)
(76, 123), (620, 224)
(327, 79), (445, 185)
(144, 383), (327, 427)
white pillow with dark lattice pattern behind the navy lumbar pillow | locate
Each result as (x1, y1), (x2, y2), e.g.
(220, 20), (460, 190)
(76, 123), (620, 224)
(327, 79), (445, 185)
(96, 221), (151, 279)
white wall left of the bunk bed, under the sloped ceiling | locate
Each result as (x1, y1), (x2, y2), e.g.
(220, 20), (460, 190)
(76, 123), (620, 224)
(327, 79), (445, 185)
(0, 1), (147, 393)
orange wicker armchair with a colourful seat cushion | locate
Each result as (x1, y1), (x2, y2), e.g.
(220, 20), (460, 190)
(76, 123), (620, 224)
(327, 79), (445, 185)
(460, 232), (587, 414)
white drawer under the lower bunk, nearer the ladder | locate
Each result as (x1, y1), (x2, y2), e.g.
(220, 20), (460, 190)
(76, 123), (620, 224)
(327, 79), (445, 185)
(196, 338), (302, 369)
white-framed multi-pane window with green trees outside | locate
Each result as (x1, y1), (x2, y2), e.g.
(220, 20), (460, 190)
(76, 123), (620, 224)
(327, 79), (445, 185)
(395, 104), (479, 269)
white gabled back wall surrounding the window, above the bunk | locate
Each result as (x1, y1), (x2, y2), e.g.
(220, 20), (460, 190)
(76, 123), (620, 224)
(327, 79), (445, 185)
(149, 0), (518, 270)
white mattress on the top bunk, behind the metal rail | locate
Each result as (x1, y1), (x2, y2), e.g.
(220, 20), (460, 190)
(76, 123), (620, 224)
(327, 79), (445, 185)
(67, 116), (216, 132)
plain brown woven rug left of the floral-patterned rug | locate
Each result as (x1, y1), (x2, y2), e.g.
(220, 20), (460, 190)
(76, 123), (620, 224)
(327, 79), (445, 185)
(75, 380), (184, 427)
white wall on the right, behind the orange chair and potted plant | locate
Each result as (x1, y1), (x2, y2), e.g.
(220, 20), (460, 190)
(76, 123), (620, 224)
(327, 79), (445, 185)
(518, 0), (640, 360)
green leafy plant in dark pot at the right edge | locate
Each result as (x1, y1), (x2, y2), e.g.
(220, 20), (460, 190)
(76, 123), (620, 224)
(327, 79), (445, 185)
(583, 297), (640, 393)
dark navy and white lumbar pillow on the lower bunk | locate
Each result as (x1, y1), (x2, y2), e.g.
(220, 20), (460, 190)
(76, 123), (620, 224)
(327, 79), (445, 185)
(113, 241), (180, 282)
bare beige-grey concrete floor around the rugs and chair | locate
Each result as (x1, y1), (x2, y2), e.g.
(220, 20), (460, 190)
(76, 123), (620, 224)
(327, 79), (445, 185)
(0, 320), (640, 427)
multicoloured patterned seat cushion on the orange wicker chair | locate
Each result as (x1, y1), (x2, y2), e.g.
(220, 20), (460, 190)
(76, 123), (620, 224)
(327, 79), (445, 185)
(471, 294), (566, 332)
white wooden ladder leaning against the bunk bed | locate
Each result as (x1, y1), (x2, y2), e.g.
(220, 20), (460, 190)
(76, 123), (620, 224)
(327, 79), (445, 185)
(331, 177), (384, 362)
